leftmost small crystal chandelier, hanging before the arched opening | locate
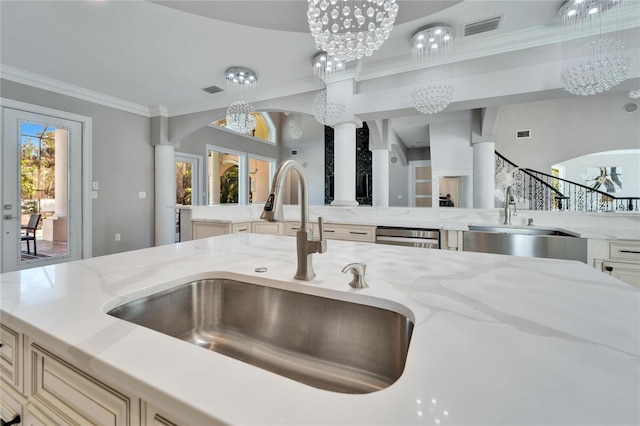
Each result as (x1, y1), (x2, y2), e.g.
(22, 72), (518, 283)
(225, 67), (258, 134)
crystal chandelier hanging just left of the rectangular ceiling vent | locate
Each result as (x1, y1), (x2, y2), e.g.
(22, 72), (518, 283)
(411, 24), (454, 114)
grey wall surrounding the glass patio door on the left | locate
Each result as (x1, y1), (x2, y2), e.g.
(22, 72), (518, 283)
(0, 80), (154, 256)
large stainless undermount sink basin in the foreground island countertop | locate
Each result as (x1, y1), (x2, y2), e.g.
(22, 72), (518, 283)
(108, 278), (413, 394)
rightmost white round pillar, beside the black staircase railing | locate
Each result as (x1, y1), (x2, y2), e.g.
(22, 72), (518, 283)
(473, 142), (495, 209)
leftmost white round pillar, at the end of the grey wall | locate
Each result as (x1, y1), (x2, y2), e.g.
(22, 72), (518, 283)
(154, 145), (176, 246)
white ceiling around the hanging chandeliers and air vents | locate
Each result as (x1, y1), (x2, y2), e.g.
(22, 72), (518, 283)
(0, 0), (640, 146)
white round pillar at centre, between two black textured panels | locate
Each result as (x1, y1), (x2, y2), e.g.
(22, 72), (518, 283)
(331, 123), (358, 206)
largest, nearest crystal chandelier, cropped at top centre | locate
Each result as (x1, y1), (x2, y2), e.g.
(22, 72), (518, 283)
(307, 0), (399, 62)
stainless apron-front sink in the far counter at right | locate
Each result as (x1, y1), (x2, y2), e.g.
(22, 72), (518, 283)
(462, 225), (587, 263)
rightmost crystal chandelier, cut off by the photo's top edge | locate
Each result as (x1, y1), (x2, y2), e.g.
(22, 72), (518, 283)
(559, 0), (631, 96)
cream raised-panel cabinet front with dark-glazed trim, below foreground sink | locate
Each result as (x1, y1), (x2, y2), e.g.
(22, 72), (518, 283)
(29, 344), (137, 426)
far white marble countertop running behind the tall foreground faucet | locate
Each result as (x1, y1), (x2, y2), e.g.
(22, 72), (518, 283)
(188, 204), (640, 240)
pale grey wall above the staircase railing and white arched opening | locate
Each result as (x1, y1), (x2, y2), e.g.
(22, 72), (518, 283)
(495, 93), (640, 171)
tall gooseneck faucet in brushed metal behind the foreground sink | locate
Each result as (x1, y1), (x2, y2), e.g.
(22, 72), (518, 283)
(260, 160), (327, 281)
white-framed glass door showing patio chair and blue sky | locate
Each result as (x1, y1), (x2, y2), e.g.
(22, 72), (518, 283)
(0, 108), (82, 272)
